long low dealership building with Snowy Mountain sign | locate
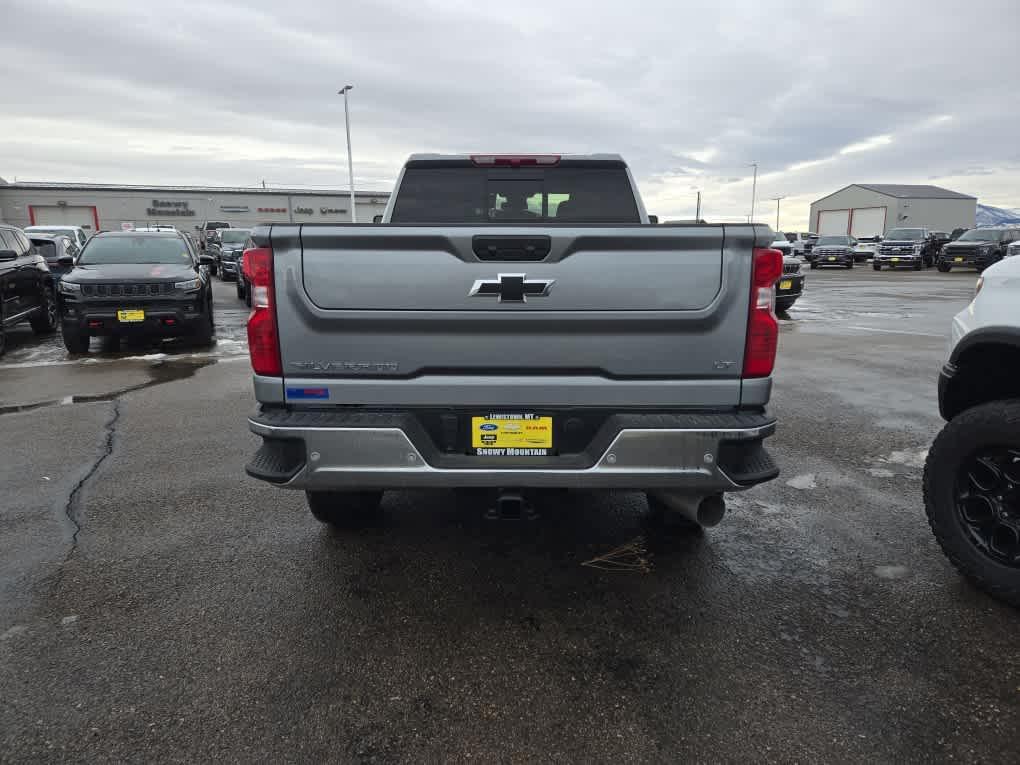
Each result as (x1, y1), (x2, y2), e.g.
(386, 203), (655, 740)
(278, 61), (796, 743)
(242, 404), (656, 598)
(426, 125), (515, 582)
(0, 181), (390, 232)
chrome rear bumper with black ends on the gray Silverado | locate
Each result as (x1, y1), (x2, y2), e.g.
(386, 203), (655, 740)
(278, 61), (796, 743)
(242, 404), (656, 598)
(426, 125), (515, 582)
(246, 409), (779, 495)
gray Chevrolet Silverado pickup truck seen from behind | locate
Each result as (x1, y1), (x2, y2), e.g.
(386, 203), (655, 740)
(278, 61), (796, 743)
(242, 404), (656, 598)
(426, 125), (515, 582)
(245, 155), (782, 525)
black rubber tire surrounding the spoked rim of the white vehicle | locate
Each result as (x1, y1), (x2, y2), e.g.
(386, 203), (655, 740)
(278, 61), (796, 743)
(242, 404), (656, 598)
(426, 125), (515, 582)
(924, 399), (1020, 607)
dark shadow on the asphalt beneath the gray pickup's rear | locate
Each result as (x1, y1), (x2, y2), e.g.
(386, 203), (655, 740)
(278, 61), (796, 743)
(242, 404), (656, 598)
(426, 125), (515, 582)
(310, 492), (711, 618)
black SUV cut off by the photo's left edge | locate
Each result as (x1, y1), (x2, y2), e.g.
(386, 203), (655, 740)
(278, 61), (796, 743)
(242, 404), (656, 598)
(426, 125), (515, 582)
(0, 224), (57, 356)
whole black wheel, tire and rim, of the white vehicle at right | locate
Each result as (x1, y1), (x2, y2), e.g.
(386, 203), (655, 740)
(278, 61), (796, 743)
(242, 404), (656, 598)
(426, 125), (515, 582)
(924, 399), (1020, 607)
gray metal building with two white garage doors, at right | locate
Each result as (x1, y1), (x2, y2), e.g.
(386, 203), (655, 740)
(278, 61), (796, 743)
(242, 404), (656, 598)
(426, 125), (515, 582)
(809, 184), (977, 237)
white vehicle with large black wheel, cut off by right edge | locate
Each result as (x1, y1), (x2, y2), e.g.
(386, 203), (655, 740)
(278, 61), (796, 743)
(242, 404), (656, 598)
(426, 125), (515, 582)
(924, 258), (1020, 607)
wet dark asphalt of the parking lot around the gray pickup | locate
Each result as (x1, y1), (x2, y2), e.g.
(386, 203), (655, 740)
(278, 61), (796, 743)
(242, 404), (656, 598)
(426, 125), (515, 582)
(0, 268), (1020, 762)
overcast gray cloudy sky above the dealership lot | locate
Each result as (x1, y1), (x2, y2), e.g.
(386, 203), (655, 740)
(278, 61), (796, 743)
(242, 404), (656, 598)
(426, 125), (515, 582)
(0, 0), (1020, 230)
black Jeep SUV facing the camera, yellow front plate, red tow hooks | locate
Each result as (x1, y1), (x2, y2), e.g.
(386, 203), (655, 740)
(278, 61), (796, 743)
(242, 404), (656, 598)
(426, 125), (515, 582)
(58, 232), (213, 353)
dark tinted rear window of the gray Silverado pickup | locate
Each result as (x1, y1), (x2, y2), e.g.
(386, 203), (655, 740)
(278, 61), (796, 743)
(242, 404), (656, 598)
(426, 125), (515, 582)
(391, 166), (641, 224)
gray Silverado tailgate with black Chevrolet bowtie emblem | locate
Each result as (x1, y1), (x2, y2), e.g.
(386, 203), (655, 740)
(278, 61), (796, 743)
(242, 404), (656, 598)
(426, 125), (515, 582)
(266, 224), (769, 408)
